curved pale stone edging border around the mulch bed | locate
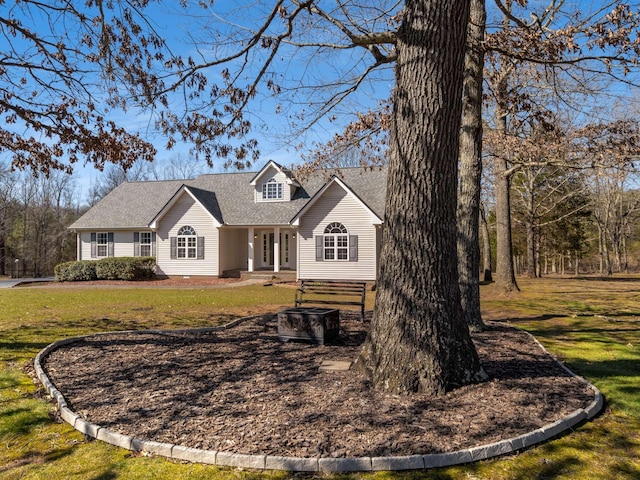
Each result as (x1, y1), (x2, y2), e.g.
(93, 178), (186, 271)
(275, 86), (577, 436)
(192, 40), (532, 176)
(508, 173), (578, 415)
(34, 317), (604, 472)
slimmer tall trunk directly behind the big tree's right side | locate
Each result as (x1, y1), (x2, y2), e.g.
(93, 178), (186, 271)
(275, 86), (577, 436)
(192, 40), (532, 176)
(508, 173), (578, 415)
(458, 0), (487, 331)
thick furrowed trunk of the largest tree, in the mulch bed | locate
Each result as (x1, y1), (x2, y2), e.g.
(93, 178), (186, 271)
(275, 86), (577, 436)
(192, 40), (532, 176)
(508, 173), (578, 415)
(358, 0), (486, 395)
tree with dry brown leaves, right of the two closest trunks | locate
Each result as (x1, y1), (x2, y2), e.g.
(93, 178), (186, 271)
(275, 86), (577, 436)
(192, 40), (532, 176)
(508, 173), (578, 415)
(487, 0), (639, 290)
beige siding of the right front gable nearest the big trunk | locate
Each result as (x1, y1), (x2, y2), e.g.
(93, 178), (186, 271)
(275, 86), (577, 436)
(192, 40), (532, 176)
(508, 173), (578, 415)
(298, 183), (378, 280)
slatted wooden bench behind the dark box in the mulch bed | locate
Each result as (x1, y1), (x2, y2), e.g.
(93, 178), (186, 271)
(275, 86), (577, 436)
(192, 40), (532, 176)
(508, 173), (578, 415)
(295, 280), (367, 321)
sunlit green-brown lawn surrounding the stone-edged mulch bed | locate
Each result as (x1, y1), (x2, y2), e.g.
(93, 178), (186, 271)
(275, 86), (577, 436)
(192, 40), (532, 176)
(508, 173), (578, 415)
(0, 277), (640, 480)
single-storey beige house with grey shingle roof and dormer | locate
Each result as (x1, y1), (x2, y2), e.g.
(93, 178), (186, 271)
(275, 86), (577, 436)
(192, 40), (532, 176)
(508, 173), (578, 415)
(70, 161), (386, 280)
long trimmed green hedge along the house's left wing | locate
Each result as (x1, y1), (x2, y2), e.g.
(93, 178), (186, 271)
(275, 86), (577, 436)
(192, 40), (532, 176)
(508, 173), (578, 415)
(54, 257), (156, 282)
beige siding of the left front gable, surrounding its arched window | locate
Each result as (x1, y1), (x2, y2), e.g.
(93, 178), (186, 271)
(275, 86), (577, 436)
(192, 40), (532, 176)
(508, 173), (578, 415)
(156, 192), (219, 276)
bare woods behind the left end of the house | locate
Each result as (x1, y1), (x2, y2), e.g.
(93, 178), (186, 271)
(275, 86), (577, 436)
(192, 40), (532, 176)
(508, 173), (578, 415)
(0, 155), (215, 277)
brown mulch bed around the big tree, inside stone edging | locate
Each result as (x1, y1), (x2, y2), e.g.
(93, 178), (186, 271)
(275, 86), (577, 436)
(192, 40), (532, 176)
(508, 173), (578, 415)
(43, 312), (594, 457)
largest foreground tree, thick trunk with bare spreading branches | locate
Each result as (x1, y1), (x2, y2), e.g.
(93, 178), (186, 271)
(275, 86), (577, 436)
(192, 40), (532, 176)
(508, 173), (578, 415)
(5, 0), (485, 395)
